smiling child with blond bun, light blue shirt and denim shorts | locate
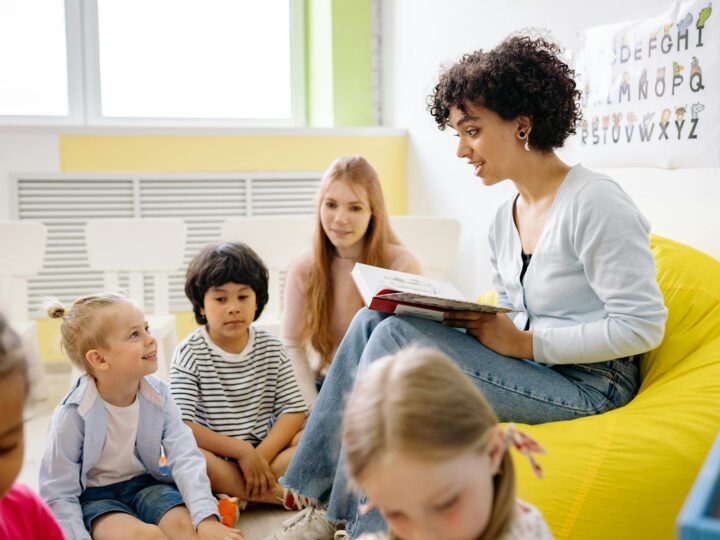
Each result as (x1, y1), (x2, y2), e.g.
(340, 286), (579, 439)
(40, 293), (243, 540)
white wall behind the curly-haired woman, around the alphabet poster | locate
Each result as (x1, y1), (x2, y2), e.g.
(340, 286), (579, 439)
(382, 0), (720, 295)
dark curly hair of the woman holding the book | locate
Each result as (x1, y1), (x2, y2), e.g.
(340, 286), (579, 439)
(427, 35), (582, 152)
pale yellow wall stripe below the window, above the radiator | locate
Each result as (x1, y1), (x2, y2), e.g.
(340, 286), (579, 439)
(60, 135), (407, 214)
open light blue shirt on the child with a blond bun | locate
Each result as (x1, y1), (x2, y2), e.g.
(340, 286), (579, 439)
(40, 375), (219, 540)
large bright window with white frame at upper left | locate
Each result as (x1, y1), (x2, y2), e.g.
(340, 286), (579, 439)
(0, 0), (305, 126)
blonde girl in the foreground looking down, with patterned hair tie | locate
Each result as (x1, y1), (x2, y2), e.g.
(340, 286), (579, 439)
(335, 347), (552, 540)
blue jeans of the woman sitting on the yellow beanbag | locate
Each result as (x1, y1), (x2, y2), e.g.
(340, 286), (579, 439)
(281, 309), (639, 537)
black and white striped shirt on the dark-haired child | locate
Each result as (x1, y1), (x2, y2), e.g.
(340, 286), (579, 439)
(170, 326), (307, 445)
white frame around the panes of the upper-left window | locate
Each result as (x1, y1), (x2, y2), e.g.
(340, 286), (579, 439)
(0, 0), (307, 128)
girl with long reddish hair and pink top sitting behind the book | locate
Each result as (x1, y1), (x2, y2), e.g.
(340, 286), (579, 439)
(280, 156), (421, 402)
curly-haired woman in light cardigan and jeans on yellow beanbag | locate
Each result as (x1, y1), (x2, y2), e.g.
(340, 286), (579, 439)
(262, 36), (667, 540)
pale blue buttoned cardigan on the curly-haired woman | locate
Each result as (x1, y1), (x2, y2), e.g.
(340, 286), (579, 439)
(489, 165), (667, 364)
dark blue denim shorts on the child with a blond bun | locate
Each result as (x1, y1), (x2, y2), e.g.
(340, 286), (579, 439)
(80, 474), (185, 531)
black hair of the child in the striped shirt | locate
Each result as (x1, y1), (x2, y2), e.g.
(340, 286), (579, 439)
(185, 242), (269, 324)
